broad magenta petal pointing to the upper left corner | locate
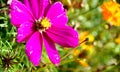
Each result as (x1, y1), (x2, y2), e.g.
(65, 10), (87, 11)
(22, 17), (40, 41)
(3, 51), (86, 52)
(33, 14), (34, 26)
(10, 0), (34, 27)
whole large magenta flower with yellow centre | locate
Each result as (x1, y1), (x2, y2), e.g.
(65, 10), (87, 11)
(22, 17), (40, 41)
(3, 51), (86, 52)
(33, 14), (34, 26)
(10, 0), (78, 66)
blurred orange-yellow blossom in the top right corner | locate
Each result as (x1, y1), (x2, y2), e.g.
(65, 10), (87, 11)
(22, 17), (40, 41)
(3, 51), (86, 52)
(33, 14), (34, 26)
(101, 0), (120, 26)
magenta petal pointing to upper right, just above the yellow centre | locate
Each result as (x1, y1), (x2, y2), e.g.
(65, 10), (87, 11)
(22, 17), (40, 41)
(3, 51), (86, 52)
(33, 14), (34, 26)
(47, 2), (68, 25)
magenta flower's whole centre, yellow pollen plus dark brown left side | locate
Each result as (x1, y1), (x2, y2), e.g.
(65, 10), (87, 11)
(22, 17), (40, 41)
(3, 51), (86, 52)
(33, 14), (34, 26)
(36, 18), (51, 31)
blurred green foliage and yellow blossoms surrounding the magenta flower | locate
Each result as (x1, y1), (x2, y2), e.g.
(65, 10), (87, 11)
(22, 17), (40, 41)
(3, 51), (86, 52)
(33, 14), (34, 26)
(0, 0), (120, 72)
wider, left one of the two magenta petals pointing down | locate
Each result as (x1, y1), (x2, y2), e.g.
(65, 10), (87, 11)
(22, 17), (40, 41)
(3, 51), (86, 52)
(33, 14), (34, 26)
(25, 32), (42, 66)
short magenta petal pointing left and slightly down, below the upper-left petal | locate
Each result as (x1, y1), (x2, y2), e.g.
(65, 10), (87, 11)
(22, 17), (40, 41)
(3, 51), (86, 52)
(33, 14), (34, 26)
(17, 22), (35, 42)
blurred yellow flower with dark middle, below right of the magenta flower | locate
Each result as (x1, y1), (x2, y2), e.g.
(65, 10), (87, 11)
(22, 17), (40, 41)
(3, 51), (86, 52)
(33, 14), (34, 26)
(73, 31), (94, 67)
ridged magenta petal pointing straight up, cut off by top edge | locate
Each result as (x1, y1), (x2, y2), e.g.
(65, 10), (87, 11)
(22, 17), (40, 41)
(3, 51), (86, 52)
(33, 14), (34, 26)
(23, 0), (50, 19)
